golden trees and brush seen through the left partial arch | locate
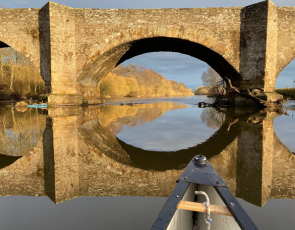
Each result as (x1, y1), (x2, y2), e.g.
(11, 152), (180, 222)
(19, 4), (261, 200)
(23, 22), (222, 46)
(0, 47), (45, 100)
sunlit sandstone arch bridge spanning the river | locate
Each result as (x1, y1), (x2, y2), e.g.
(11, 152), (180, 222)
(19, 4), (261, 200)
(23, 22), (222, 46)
(0, 0), (295, 104)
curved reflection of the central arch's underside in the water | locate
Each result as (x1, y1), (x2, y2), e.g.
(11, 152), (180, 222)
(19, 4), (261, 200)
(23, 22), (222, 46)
(79, 115), (239, 171)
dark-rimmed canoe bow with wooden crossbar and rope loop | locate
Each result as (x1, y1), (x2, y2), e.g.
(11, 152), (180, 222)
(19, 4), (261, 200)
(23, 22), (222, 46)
(150, 155), (258, 230)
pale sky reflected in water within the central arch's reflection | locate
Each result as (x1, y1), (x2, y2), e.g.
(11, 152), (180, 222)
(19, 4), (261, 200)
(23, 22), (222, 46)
(116, 106), (219, 152)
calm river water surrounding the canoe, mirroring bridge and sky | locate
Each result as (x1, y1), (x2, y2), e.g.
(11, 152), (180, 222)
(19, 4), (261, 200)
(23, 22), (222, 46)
(0, 96), (295, 230)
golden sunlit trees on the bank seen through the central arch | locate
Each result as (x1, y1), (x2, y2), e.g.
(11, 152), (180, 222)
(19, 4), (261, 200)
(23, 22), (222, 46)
(100, 64), (193, 97)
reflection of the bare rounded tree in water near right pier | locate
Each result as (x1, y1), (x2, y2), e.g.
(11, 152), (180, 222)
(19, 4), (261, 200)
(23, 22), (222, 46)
(201, 108), (225, 129)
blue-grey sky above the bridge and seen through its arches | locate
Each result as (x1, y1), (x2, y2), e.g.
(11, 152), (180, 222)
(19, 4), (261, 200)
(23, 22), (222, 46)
(0, 0), (295, 89)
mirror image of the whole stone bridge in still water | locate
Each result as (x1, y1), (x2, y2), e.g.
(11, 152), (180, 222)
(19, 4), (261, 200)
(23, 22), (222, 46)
(0, 106), (295, 206)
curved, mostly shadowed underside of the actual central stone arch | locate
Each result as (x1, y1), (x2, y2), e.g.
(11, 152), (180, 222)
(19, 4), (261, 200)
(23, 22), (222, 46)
(78, 36), (241, 87)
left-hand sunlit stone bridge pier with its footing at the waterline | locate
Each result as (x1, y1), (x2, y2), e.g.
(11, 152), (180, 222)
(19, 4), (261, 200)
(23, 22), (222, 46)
(39, 2), (101, 105)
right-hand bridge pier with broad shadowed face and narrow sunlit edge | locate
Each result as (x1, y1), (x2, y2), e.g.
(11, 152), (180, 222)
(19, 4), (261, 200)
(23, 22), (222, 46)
(240, 1), (278, 93)
